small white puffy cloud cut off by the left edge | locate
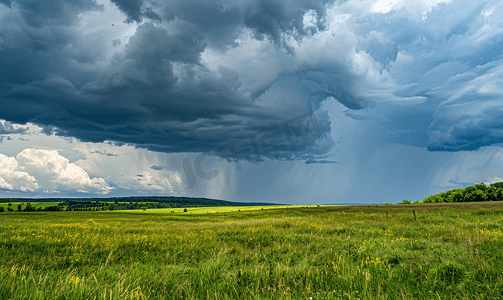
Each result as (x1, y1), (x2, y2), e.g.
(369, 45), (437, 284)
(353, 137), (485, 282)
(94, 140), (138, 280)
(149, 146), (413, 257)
(0, 154), (38, 192)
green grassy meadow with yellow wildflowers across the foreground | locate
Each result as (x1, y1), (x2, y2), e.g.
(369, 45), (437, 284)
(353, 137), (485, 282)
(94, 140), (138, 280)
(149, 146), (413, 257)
(0, 202), (503, 299)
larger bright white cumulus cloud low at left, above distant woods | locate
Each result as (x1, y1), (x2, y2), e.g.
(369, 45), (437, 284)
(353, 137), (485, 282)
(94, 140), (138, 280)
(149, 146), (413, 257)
(17, 149), (114, 195)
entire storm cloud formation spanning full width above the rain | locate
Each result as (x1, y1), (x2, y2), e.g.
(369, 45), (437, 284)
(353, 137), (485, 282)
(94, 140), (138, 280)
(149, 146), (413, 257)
(0, 0), (503, 165)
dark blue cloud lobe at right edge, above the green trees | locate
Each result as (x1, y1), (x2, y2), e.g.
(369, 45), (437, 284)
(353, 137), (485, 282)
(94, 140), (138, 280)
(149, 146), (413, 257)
(426, 56), (503, 151)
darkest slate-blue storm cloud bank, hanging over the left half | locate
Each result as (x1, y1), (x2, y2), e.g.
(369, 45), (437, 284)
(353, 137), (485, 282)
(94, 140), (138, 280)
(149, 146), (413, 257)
(0, 1), (342, 162)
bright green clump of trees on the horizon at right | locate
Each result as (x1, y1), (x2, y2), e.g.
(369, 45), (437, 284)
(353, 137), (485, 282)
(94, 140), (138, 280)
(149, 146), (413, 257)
(423, 182), (503, 203)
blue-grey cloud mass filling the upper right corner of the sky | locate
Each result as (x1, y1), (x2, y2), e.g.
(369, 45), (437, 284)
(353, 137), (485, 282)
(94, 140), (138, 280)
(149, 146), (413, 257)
(347, 1), (503, 151)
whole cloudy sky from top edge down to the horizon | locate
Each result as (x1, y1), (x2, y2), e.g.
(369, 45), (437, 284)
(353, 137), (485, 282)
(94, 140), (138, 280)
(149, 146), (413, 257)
(0, 0), (503, 204)
